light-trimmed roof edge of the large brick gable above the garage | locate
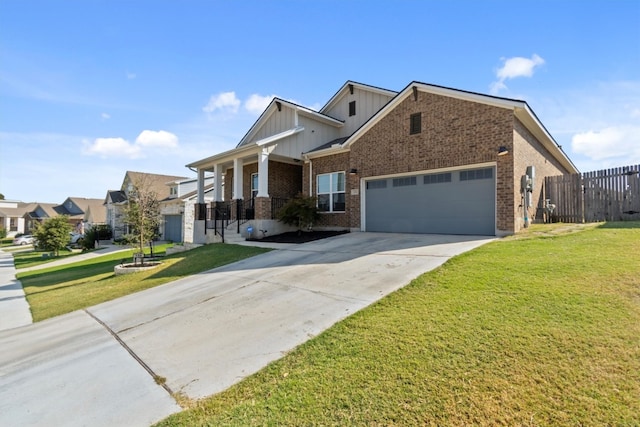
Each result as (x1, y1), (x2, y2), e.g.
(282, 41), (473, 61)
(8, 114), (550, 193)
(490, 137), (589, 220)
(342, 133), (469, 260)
(305, 81), (578, 173)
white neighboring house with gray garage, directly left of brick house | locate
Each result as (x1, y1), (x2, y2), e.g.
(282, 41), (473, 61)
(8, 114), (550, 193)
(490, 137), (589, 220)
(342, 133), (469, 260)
(160, 176), (213, 242)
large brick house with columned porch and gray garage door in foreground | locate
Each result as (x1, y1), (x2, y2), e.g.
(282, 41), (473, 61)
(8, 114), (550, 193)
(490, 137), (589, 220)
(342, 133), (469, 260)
(187, 81), (577, 243)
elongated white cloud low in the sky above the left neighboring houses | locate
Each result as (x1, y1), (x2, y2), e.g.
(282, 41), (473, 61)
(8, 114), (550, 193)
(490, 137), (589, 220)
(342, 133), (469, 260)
(82, 130), (178, 159)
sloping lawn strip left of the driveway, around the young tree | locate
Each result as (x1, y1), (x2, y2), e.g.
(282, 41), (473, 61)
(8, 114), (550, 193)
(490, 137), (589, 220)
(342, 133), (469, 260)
(17, 244), (268, 322)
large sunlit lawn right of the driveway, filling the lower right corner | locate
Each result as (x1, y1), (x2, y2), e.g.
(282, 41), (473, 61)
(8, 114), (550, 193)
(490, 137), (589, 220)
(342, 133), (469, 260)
(159, 222), (640, 426)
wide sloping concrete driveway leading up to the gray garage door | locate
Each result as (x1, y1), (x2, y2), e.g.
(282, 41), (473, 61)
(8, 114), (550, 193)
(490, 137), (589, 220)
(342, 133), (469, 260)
(0, 233), (493, 426)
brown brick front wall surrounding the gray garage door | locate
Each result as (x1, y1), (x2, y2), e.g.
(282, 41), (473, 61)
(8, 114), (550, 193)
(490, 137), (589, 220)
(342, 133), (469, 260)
(349, 92), (513, 232)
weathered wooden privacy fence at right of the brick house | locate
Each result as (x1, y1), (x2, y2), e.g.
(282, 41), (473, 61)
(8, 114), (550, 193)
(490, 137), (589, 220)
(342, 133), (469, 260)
(544, 165), (640, 222)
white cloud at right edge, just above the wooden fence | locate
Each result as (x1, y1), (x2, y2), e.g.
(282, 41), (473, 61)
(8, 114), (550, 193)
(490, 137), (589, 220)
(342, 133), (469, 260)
(571, 125), (640, 164)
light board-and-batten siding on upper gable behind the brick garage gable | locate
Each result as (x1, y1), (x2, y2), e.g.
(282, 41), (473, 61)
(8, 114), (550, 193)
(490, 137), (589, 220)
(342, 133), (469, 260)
(324, 87), (392, 137)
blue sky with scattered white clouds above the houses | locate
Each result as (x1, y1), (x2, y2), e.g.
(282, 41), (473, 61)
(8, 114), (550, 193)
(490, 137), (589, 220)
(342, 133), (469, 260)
(0, 0), (640, 203)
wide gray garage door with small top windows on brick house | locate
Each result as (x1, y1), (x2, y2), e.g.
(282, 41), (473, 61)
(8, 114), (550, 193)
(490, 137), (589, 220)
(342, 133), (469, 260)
(365, 167), (496, 235)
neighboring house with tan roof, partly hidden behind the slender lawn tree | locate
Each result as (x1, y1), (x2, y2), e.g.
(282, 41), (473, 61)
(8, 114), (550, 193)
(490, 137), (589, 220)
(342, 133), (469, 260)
(103, 171), (187, 239)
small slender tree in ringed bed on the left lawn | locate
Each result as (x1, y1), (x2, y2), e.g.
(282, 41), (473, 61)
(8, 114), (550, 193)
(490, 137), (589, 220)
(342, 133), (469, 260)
(125, 176), (160, 262)
